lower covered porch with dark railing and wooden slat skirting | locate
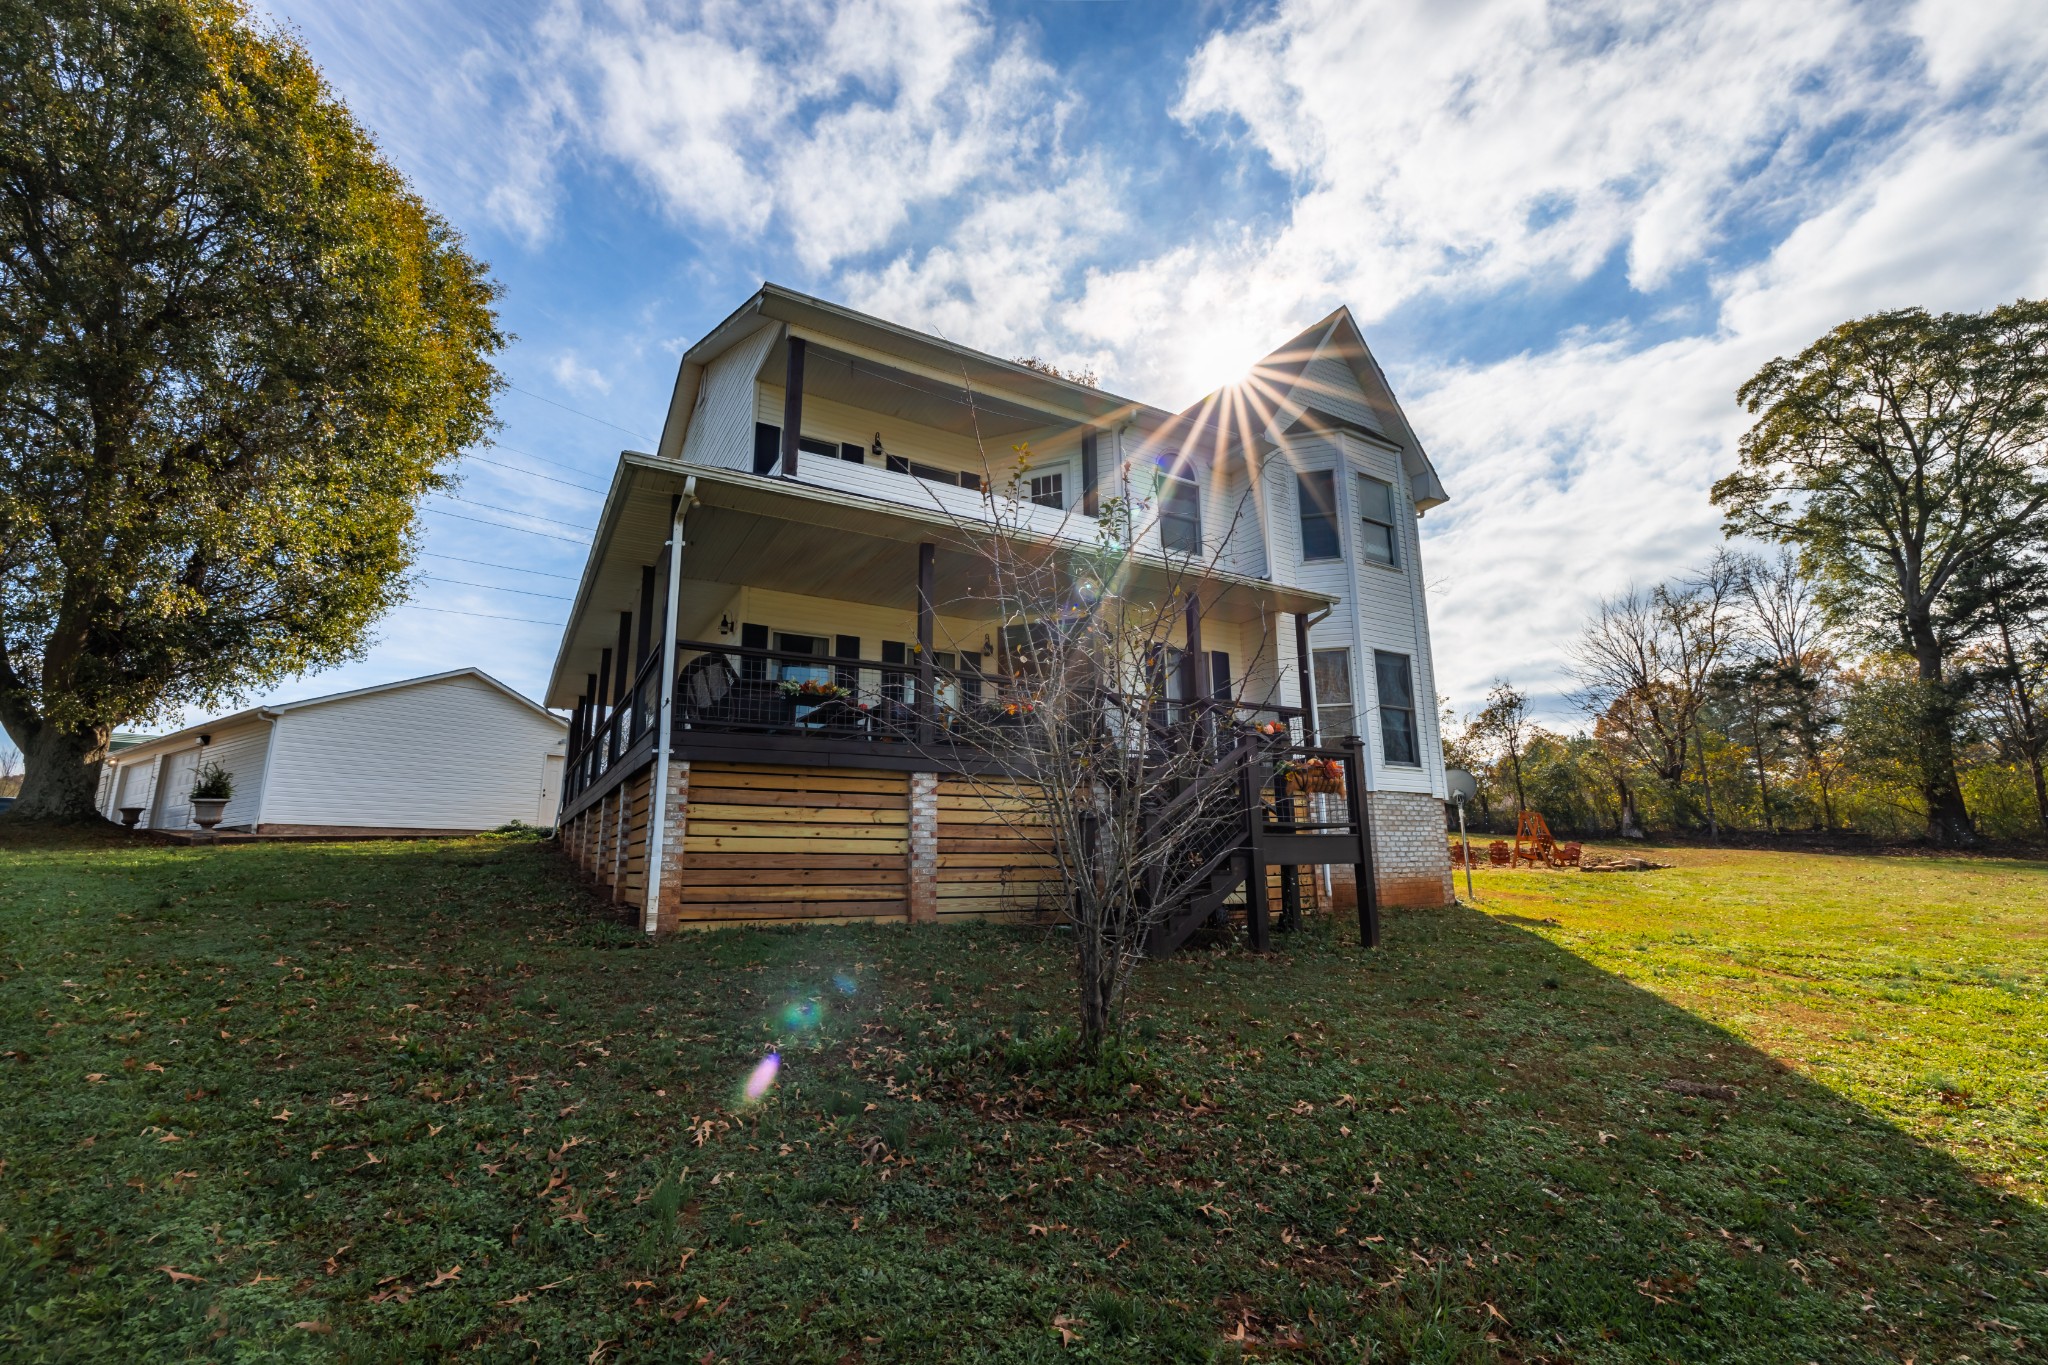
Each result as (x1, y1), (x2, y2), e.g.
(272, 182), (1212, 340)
(549, 456), (1360, 931)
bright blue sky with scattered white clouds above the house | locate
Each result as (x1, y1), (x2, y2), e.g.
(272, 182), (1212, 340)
(99, 0), (2048, 749)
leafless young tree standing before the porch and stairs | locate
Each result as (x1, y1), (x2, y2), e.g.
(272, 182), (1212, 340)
(920, 446), (1302, 1056)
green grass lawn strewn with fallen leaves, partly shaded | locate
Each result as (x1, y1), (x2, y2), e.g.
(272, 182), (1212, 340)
(0, 835), (2048, 1365)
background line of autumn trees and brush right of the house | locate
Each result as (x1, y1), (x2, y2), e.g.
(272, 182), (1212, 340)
(1444, 551), (2048, 841)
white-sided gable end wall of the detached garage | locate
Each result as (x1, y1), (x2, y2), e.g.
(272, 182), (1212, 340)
(262, 675), (563, 829)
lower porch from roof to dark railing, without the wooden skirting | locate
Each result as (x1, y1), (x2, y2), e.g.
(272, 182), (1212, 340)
(547, 454), (1331, 810)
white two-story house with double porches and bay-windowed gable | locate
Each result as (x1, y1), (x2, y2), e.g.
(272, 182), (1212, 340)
(545, 284), (1452, 945)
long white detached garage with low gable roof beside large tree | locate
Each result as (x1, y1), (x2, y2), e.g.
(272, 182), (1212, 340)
(100, 669), (569, 835)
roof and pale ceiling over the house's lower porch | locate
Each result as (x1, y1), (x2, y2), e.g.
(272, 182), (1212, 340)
(545, 462), (1335, 706)
